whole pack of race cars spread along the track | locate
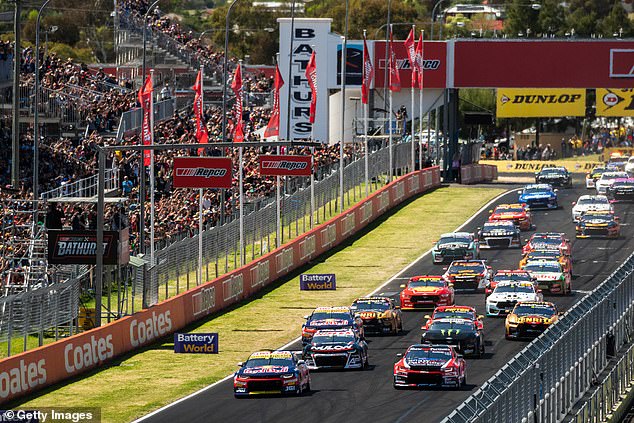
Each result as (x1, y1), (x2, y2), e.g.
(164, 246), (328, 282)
(234, 165), (634, 397)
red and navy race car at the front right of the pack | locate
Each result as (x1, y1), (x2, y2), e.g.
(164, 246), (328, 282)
(394, 344), (467, 389)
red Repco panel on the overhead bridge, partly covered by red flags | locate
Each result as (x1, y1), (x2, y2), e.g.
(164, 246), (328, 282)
(374, 41), (447, 88)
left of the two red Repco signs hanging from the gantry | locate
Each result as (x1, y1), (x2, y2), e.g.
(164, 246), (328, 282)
(173, 157), (232, 188)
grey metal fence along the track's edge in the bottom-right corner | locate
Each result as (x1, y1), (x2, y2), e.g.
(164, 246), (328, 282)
(443, 254), (634, 423)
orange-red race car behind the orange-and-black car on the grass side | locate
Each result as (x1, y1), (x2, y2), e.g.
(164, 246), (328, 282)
(401, 275), (454, 310)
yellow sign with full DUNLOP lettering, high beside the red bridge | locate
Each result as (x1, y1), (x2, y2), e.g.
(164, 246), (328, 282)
(497, 88), (586, 118)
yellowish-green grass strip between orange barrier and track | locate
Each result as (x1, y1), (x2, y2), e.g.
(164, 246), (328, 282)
(14, 186), (504, 422)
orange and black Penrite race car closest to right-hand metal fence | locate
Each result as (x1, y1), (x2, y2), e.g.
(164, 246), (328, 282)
(504, 301), (562, 339)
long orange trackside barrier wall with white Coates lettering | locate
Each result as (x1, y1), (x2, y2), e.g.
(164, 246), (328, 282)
(0, 167), (440, 403)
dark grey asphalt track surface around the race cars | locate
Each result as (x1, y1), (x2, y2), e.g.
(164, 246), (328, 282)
(143, 185), (634, 423)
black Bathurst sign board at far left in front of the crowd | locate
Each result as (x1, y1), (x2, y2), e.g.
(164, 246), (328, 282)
(48, 229), (120, 265)
